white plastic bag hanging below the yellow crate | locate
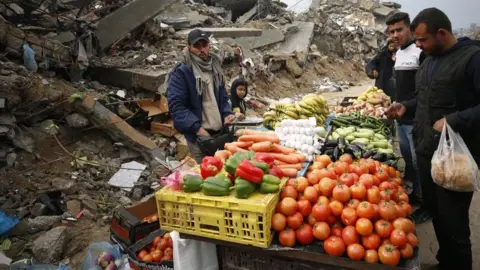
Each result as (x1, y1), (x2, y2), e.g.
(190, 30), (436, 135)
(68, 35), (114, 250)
(170, 231), (219, 270)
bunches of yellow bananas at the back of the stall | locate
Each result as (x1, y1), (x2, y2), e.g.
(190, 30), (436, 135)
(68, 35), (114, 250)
(263, 94), (329, 129)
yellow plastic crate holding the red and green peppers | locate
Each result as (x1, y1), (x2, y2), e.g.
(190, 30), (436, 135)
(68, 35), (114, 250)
(155, 179), (287, 248)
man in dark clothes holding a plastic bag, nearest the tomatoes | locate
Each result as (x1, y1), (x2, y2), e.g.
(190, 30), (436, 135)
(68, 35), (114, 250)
(387, 8), (480, 270)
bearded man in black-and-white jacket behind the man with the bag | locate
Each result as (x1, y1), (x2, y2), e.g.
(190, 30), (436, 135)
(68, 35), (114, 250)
(387, 12), (430, 218)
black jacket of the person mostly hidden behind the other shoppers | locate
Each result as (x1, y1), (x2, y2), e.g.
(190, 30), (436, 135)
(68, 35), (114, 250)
(365, 48), (395, 100)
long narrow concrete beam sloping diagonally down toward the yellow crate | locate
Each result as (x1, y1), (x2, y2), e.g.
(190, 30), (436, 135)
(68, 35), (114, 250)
(75, 96), (165, 161)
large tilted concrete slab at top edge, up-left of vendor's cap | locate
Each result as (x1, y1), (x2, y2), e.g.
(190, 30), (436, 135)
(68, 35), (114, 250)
(95, 0), (176, 49)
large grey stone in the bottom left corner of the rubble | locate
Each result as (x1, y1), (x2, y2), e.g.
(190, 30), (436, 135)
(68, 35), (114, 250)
(32, 226), (68, 263)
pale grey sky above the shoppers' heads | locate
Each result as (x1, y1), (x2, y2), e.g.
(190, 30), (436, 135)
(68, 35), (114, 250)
(394, 0), (480, 29)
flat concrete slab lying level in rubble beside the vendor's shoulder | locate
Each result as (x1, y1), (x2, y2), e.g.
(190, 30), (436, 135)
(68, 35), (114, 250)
(92, 67), (168, 92)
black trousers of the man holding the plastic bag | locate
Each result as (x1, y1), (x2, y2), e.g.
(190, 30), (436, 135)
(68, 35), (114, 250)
(417, 153), (473, 270)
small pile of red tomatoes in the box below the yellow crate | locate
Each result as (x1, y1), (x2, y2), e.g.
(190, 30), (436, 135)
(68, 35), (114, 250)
(137, 233), (173, 263)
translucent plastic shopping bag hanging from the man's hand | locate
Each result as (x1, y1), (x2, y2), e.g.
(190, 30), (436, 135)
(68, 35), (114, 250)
(431, 121), (480, 192)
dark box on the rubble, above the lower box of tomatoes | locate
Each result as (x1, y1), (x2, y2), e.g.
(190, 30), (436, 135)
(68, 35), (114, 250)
(110, 196), (160, 246)
